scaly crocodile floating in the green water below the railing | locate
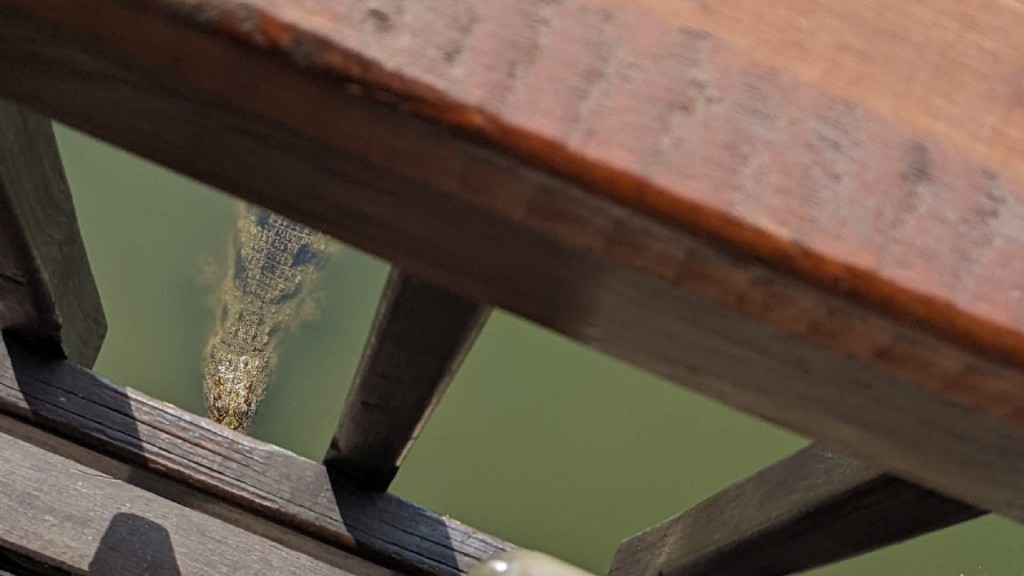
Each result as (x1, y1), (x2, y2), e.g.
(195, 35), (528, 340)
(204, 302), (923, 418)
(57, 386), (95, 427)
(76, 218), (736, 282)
(203, 206), (331, 431)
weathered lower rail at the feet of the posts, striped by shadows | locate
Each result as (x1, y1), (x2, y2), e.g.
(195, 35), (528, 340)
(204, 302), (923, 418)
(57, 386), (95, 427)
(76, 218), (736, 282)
(0, 334), (513, 576)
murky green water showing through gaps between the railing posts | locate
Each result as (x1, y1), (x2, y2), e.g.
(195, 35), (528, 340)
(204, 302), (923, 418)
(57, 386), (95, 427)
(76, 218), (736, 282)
(57, 125), (1024, 576)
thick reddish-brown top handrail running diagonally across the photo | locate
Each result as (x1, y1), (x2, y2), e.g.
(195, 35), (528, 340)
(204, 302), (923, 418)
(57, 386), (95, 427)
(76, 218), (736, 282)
(6, 0), (1024, 520)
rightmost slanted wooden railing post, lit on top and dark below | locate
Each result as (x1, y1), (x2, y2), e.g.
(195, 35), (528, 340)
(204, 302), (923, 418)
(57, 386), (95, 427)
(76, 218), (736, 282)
(609, 446), (984, 576)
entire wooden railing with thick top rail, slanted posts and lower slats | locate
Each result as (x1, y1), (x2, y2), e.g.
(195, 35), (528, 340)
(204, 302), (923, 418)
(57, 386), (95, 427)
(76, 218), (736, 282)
(0, 0), (1024, 576)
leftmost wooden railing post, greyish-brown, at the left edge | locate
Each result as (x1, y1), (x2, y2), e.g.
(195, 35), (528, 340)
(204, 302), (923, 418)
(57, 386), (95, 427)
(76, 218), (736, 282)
(0, 100), (106, 367)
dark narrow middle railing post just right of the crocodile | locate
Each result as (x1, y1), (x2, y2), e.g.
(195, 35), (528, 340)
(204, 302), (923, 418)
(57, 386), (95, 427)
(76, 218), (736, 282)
(324, 269), (488, 490)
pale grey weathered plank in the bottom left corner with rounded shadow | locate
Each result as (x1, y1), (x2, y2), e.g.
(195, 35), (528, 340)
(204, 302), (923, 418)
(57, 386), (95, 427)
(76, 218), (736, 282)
(0, 416), (399, 576)
